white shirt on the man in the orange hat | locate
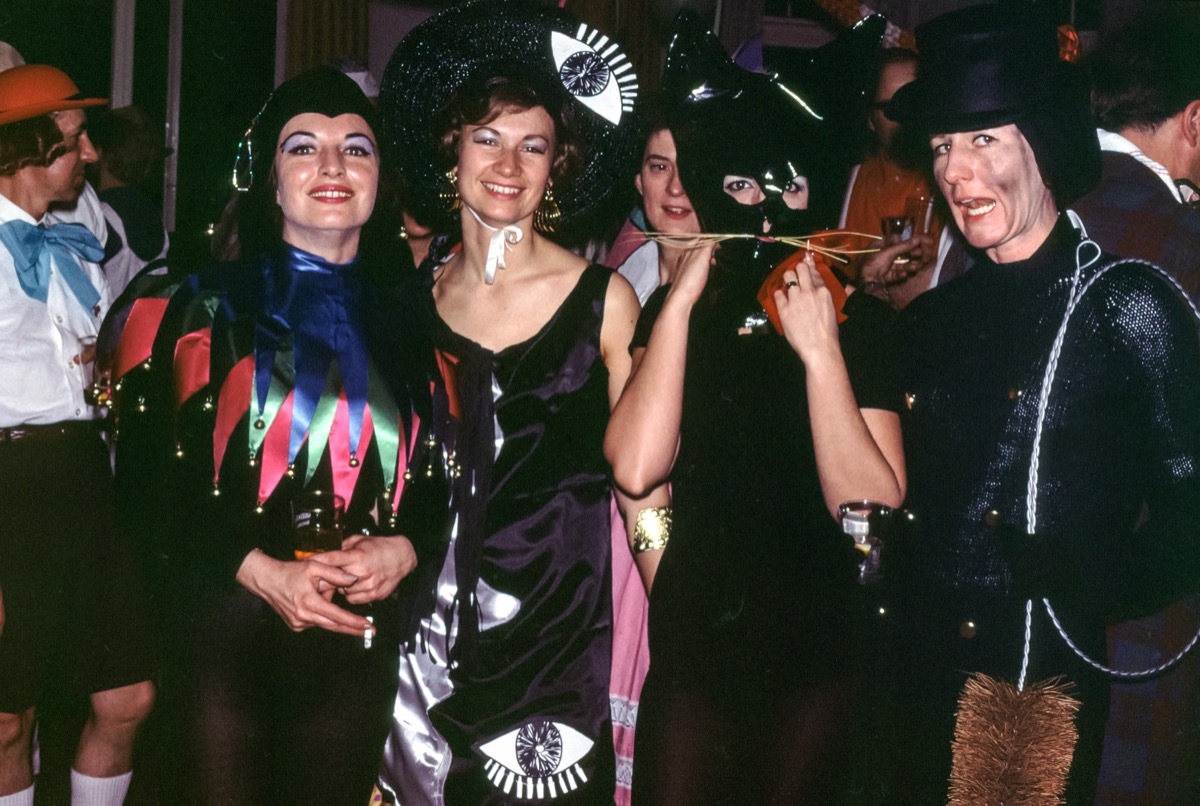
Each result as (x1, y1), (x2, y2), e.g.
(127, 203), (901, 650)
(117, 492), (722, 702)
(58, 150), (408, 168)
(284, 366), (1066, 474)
(0, 196), (113, 428)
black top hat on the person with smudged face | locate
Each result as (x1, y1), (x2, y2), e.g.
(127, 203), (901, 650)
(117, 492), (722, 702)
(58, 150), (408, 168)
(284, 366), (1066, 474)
(886, 5), (1086, 134)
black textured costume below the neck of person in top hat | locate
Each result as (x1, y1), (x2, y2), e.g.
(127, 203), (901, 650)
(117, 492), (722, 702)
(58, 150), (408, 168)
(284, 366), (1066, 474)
(893, 218), (1200, 806)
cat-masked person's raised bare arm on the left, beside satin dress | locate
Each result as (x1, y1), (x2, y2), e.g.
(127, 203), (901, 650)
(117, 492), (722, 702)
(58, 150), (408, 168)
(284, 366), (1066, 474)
(605, 246), (712, 498)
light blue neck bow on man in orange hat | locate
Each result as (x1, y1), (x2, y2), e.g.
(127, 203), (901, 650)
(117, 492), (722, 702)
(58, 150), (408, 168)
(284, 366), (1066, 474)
(0, 221), (104, 315)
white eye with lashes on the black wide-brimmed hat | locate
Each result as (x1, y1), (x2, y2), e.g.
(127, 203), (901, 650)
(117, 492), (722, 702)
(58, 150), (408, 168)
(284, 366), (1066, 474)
(550, 24), (638, 125)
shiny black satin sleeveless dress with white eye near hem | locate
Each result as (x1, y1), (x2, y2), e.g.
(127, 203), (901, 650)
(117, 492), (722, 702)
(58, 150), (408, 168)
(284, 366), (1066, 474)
(380, 265), (616, 806)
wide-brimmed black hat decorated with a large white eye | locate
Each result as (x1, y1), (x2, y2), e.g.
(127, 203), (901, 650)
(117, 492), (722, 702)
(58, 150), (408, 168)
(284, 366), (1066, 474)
(379, 0), (642, 227)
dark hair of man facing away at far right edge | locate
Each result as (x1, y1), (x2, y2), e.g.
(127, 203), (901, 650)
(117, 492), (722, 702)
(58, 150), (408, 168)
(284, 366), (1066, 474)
(1086, 4), (1200, 132)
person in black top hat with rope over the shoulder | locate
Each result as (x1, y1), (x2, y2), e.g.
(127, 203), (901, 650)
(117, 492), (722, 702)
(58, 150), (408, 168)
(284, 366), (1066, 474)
(888, 6), (1200, 805)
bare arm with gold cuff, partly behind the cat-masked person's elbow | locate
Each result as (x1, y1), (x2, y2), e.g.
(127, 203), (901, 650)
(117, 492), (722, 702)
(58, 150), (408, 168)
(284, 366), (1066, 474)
(600, 275), (671, 593)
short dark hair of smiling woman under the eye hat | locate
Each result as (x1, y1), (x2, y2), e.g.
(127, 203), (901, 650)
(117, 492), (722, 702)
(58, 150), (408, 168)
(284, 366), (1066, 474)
(438, 76), (580, 181)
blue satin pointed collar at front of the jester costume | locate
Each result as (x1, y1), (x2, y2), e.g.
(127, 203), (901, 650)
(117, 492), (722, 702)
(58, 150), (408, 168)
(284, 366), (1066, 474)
(254, 245), (367, 464)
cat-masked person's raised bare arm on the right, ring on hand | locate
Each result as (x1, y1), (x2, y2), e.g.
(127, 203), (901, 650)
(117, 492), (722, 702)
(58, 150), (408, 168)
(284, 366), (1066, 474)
(775, 251), (906, 517)
